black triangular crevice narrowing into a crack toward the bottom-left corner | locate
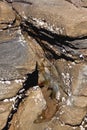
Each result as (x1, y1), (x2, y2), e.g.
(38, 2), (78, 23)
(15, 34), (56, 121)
(2, 63), (38, 130)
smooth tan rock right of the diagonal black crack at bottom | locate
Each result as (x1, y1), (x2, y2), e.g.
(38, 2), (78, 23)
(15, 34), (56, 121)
(10, 88), (46, 130)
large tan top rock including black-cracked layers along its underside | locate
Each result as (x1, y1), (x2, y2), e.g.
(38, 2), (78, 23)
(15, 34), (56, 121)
(12, 1), (87, 60)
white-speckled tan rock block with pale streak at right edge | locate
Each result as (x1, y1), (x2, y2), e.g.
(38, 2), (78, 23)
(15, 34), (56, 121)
(55, 60), (87, 96)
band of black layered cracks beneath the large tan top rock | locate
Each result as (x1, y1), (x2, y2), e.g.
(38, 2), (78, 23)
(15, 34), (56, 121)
(21, 21), (79, 61)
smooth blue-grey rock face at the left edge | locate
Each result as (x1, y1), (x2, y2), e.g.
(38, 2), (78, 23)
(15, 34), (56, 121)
(0, 30), (28, 80)
